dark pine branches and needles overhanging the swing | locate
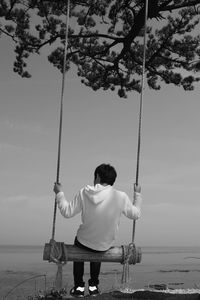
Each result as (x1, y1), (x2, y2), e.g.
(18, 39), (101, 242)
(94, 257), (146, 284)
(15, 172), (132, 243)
(0, 0), (200, 97)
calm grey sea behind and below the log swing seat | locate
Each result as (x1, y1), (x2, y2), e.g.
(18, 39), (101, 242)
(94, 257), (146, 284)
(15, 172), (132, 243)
(0, 245), (200, 300)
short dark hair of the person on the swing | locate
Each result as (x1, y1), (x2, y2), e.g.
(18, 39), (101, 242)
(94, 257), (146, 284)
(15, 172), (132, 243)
(94, 164), (117, 185)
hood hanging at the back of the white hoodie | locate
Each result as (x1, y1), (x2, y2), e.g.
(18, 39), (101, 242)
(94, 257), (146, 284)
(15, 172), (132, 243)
(83, 183), (112, 204)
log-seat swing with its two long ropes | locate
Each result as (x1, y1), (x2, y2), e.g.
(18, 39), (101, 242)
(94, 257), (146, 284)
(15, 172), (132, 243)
(43, 0), (148, 290)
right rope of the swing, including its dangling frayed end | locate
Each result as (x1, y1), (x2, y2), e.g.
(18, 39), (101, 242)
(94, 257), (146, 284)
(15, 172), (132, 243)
(121, 0), (148, 284)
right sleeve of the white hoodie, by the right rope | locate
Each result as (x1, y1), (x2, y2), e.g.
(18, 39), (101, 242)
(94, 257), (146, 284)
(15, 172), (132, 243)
(123, 192), (142, 220)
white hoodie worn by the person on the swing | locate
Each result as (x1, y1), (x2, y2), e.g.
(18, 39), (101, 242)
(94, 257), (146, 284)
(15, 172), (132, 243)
(56, 184), (142, 251)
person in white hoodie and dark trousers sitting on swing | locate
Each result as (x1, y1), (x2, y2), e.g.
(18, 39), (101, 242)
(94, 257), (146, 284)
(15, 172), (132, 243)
(54, 164), (142, 297)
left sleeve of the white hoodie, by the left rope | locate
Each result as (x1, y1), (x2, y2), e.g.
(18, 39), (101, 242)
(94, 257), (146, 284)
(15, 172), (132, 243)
(56, 192), (82, 218)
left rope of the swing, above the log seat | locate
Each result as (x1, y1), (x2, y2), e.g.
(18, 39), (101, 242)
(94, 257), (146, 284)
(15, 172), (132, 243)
(52, 0), (70, 240)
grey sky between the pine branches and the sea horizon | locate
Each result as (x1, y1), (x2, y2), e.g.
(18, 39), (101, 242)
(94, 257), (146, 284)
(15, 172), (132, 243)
(0, 31), (200, 246)
